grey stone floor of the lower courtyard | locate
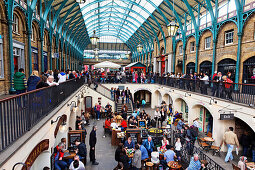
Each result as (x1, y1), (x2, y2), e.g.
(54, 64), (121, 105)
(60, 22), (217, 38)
(83, 105), (241, 170)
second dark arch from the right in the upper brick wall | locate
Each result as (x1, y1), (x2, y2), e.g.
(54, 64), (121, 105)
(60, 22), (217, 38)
(218, 58), (236, 81)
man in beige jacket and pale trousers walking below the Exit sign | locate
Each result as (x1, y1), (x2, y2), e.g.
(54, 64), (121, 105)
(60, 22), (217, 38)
(221, 127), (239, 162)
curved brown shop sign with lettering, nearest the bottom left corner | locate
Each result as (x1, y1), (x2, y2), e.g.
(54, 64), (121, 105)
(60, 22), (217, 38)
(22, 139), (49, 170)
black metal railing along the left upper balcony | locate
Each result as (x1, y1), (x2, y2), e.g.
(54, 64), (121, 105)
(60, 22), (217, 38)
(0, 77), (84, 152)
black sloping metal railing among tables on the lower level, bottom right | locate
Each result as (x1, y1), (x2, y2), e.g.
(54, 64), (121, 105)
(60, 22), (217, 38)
(170, 130), (224, 170)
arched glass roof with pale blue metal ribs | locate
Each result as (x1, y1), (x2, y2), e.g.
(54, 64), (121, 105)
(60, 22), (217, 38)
(80, 0), (163, 43)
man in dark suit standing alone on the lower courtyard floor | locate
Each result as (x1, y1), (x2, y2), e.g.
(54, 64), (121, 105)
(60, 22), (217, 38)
(89, 126), (99, 165)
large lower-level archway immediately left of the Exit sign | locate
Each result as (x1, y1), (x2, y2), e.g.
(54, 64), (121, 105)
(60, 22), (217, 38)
(189, 105), (213, 134)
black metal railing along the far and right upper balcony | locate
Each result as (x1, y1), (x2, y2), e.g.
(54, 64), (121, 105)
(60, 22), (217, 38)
(95, 75), (255, 106)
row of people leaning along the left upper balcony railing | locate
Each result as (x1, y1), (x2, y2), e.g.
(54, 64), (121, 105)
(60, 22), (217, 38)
(12, 68), (84, 94)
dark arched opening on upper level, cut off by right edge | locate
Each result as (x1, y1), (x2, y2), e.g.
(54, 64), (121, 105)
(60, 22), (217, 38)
(243, 56), (255, 84)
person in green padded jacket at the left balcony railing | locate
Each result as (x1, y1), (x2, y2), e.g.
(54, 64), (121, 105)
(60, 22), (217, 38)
(12, 68), (27, 94)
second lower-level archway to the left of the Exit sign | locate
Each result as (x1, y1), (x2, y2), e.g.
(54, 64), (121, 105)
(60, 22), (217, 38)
(174, 98), (189, 122)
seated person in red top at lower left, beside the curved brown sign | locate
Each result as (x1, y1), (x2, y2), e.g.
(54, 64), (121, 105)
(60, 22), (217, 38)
(54, 142), (68, 170)
